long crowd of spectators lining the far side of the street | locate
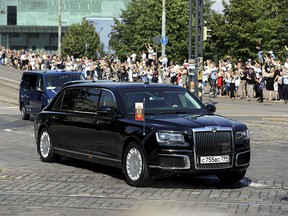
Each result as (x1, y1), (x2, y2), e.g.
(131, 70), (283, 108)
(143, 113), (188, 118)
(0, 44), (288, 103)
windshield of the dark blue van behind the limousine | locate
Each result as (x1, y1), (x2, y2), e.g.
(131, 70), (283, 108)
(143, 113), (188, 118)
(45, 73), (84, 89)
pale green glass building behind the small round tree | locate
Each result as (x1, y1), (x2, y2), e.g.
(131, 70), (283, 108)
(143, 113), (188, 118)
(0, 0), (131, 52)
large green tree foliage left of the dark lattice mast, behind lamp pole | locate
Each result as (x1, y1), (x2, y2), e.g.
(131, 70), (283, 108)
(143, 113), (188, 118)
(110, 0), (194, 61)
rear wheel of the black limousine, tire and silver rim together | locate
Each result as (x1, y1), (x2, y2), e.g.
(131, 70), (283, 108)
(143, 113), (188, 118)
(37, 128), (57, 162)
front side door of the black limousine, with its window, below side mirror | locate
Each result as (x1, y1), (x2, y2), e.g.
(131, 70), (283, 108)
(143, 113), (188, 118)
(91, 89), (123, 159)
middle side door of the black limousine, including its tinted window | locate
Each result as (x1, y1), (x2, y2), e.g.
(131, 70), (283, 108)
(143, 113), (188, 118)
(70, 87), (101, 154)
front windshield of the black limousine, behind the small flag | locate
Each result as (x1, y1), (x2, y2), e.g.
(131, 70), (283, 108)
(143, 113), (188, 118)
(121, 88), (207, 115)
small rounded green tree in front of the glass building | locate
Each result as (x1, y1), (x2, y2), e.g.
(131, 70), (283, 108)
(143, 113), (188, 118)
(61, 20), (103, 58)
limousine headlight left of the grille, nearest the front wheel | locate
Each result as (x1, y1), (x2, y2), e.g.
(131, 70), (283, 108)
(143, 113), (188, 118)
(156, 132), (185, 145)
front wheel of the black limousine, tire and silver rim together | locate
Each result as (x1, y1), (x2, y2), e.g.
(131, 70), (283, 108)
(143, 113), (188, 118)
(123, 142), (153, 187)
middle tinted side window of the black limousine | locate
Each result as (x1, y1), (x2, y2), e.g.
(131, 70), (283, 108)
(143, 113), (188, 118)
(76, 88), (100, 112)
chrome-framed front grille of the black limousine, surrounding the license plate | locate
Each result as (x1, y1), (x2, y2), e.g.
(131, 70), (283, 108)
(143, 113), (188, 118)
(193, 127), (233, 170)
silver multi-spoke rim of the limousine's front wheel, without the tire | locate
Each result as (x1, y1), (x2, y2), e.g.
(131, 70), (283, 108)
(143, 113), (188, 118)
(126, 148), (143, 181)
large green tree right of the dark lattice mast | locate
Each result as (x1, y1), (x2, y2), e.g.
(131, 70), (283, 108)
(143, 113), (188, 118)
(205, 0), (288, 62)
